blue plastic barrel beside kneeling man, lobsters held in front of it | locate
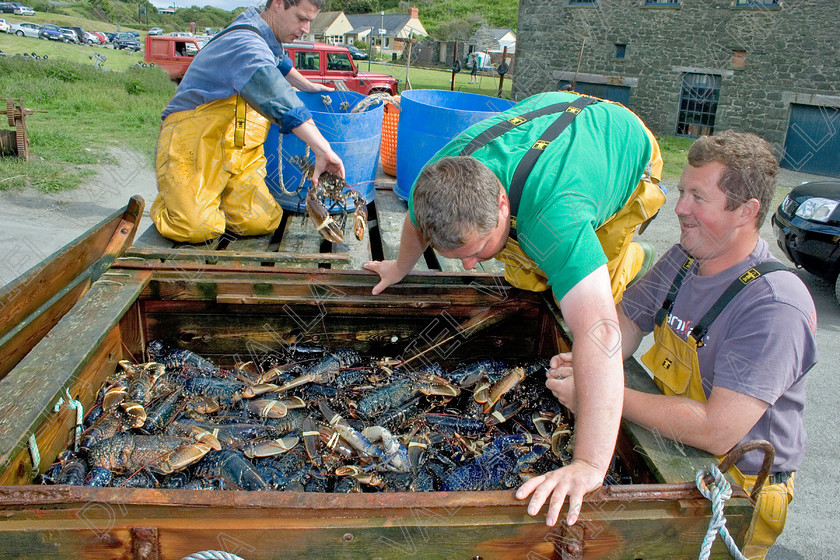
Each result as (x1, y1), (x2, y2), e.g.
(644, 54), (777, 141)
(263, 91), (384, 213)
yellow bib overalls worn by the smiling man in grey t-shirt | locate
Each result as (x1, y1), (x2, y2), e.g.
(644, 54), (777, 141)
(642, 257), (795, 560)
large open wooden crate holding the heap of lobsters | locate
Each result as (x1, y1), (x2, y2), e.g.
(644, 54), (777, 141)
(0, 193), (768, 560)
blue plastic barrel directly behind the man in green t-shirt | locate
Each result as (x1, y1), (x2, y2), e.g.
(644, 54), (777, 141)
(394, 89), (514, 199)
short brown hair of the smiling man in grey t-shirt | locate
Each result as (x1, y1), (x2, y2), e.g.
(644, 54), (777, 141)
(688, 130), (779, 229)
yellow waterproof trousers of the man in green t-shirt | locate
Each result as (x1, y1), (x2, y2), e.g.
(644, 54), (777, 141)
(496, 128), (665, 303)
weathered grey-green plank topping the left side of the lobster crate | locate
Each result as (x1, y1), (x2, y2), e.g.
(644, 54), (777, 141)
(0, 271), (151, 476)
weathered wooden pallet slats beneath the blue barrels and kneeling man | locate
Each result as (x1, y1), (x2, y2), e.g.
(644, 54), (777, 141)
(125, 184), (503, 274)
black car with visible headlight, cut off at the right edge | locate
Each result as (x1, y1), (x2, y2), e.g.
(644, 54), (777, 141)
(770, 180), (840, 303)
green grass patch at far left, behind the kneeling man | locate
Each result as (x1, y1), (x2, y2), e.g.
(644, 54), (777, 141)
(0, 54), (175, 192)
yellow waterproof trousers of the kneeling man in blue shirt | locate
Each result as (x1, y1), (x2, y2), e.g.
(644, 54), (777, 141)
(149, 96), (283, 243)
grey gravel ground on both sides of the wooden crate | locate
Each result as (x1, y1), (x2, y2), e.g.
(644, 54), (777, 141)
(0, 149), (840, 560)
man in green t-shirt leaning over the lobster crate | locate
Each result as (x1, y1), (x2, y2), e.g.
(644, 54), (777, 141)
(365, 92), (665, 525)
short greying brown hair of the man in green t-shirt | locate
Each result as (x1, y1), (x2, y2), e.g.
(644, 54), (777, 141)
(412, 156), (502, 251)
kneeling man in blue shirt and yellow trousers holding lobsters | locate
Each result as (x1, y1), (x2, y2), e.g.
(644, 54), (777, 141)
(149, 0), (344, 243)
